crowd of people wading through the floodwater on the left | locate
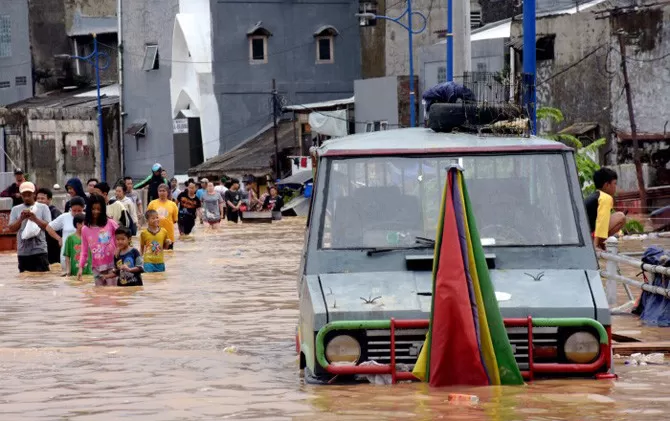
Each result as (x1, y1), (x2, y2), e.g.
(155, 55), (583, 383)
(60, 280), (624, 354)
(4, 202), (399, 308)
(0, 164), (283, 286)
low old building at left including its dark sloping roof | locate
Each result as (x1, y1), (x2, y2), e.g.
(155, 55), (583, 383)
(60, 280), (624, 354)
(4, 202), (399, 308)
(0, 85), (121, 186)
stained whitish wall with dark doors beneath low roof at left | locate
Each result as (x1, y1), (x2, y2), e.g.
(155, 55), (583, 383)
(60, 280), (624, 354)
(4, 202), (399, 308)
(0, 105), (121, 186)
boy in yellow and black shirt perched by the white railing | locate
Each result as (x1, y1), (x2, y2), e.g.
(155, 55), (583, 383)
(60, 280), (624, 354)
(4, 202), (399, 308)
(584, 168), (626, 250)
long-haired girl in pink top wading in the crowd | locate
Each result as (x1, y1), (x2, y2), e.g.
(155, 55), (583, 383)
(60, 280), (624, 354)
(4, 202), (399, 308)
(77, 194), (119, 286)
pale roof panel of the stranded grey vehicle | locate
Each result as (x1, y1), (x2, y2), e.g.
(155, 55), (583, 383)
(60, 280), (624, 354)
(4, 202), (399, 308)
(319, 128), (567, 154)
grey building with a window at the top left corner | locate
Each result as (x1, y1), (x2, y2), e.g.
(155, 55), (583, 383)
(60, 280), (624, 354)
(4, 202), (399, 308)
(0, 0), (33, 106)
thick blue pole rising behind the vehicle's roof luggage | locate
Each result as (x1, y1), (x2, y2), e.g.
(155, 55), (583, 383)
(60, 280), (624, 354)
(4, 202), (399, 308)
(523, 0), (537, 135)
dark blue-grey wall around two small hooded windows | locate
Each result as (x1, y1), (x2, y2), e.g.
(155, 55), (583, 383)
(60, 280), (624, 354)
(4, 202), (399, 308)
(211, 0), (361, 153)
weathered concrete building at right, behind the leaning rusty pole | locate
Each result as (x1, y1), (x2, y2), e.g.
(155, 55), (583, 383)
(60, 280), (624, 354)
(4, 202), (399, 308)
(510, 0), (670, 186)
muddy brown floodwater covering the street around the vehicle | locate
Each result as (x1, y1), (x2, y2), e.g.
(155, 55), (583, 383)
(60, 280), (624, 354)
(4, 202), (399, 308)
(0, 219), (670, 421)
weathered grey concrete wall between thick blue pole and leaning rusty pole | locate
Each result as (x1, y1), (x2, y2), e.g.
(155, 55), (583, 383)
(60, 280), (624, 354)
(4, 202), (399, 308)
(512, 9), (611, 136)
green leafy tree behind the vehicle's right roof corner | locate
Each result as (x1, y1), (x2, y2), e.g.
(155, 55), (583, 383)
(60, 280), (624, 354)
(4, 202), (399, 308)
(537, 107), (607, 196)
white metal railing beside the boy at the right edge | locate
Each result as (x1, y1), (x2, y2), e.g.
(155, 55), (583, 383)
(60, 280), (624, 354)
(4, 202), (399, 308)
(597, 237), (670, 313)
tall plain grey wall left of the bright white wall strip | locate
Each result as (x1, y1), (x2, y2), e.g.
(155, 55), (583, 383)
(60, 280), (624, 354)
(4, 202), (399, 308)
(122, 0), (179, 178)
